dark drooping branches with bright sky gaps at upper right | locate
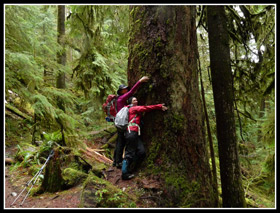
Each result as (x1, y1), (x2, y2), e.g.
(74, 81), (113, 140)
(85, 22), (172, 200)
(227, 5), (275, 105)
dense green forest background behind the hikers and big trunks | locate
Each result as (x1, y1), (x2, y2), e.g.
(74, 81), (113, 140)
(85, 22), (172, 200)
(4, 5), (276, 208)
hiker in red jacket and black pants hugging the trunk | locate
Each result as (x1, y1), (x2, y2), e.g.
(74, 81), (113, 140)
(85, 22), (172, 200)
(122, 97), (167, 180)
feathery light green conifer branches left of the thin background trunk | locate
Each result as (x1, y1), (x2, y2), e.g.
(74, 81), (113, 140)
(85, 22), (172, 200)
(5, 5), (77, 141)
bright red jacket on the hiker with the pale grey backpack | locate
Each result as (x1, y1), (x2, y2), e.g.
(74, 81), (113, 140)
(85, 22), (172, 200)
(128, 104), (162, 133)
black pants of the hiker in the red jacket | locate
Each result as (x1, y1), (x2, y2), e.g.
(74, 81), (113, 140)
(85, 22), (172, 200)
(123, 131), (146, 173)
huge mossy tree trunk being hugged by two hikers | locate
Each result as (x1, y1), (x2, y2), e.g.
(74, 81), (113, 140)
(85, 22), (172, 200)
(128, 6), (213, 207)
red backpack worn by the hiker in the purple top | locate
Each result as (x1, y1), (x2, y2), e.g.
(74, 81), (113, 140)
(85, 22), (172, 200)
(102, 95), (118, 122)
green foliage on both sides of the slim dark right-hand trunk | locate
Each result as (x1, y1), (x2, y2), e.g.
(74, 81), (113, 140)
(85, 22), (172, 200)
(197, 5), (275, 206)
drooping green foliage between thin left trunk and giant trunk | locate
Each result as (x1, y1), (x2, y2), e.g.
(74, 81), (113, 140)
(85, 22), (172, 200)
(68, 5), (127, 100)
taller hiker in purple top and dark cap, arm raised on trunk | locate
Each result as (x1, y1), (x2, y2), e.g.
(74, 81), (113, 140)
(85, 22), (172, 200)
(113, 76), (149, 169)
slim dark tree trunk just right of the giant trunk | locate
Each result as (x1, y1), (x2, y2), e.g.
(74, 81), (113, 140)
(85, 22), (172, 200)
(207, 6), (246, 207)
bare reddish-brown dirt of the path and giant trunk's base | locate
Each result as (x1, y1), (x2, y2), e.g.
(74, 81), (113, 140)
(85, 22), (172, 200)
(5, 167), (160, 208)
